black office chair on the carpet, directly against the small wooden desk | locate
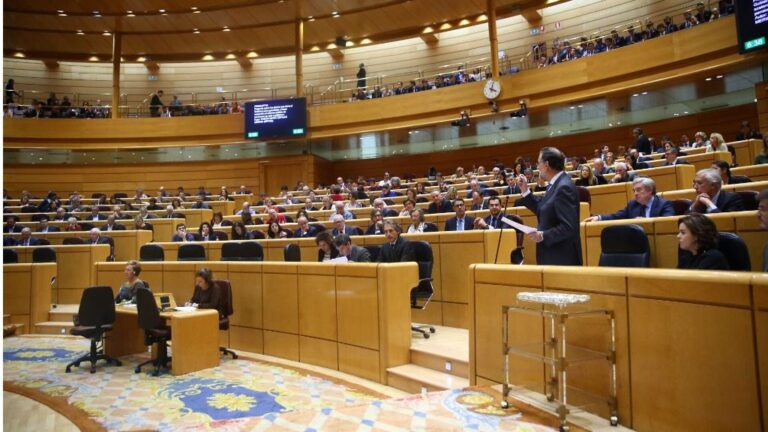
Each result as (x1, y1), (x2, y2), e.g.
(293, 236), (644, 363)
(134, 288), (171, 376)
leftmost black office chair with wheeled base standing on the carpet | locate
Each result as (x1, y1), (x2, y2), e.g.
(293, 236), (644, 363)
(66, 286), (122, 373)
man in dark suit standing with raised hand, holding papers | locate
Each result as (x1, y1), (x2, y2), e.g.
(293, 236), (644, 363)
(517, 147), (582, 265)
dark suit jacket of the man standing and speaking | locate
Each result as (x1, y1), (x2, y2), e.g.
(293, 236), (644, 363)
(520, 174), (582, 265)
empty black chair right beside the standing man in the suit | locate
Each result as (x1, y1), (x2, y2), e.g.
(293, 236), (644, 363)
(599, 224), (651, 267)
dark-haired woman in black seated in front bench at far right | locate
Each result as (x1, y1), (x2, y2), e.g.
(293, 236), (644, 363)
(677, 214), (728, 270)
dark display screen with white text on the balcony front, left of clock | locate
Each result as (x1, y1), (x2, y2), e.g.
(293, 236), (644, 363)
(245, 98), (307, 140)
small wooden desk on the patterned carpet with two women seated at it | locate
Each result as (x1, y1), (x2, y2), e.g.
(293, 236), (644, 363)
(104, 306), (219, 375)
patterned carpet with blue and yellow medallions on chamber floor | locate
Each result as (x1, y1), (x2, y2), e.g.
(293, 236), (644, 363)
(3, 336), (552, 432)
